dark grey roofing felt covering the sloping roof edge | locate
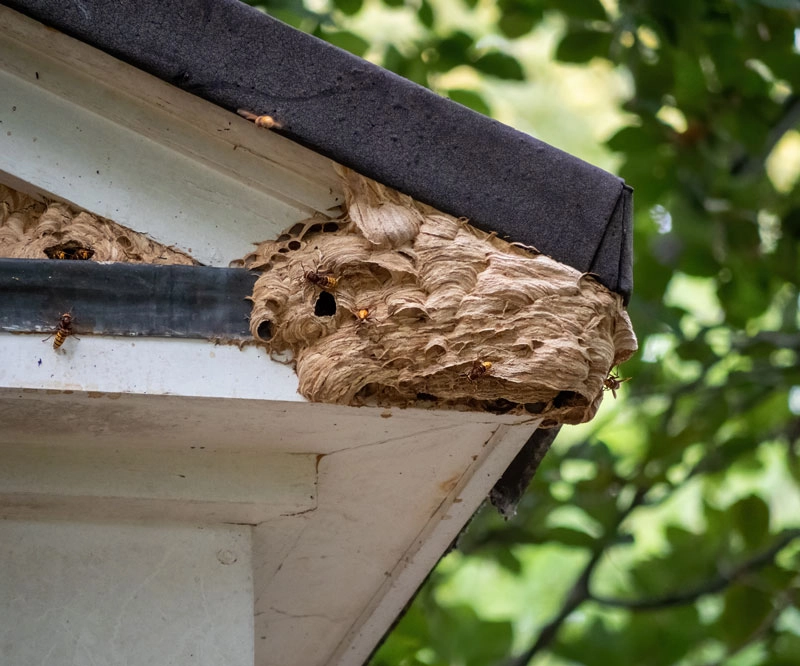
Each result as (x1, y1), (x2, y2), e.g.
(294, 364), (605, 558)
(8, 0), (633, 300)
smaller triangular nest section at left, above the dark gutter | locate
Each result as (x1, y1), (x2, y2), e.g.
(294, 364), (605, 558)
(0, 184), (196, 265)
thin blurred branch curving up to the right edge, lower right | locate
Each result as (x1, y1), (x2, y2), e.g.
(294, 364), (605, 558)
(589, 529), (800, 611)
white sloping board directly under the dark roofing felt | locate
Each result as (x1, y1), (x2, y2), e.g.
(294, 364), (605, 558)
(0, 7), (344, 266)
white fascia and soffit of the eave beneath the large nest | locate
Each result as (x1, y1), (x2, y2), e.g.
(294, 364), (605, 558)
(0, 334), (537, 666)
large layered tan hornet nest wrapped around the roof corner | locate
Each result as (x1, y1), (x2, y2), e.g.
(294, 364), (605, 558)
(239, 170), (636, 425)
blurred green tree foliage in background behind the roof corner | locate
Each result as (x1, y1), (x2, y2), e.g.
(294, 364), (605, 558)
(241, 0), (800, 666)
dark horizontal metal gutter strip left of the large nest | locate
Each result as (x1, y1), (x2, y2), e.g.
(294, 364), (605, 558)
(0, 259), (258, 340)
